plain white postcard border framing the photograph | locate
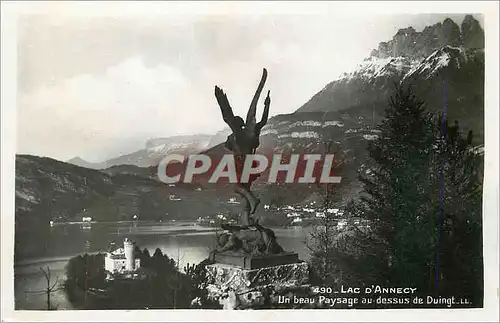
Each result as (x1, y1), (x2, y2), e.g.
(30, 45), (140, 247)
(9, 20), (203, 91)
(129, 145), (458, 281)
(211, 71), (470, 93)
(1, 1), (499, 322)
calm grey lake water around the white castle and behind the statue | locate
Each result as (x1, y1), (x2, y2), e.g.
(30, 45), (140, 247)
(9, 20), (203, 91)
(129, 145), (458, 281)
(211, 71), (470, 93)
(14, 222), (309, 310)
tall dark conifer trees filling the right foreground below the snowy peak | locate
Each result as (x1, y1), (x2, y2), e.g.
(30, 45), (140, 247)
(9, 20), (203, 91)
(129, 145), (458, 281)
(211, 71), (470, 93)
(308, 86), (482, 306)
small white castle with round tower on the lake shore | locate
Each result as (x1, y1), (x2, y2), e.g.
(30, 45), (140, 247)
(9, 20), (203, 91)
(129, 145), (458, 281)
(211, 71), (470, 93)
(104, 238), (141, 279)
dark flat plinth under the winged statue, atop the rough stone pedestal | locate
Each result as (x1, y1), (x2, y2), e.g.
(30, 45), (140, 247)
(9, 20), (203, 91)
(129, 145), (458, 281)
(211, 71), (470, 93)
(214, 251), (299, 269)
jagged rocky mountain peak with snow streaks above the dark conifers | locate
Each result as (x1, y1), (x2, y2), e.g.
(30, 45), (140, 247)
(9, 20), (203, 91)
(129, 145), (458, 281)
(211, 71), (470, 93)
(297, 16), (484, 136)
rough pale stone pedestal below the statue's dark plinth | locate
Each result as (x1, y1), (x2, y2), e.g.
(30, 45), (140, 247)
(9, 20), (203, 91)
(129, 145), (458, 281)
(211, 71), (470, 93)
(206, 262), (309, 309)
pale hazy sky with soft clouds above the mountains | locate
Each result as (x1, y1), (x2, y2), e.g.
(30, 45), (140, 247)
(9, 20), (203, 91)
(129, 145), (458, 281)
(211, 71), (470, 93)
(17, 13), (480, 161)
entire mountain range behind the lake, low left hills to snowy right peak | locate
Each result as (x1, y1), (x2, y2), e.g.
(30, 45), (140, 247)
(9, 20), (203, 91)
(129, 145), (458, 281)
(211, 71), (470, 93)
(16, 15), (484, 260)
